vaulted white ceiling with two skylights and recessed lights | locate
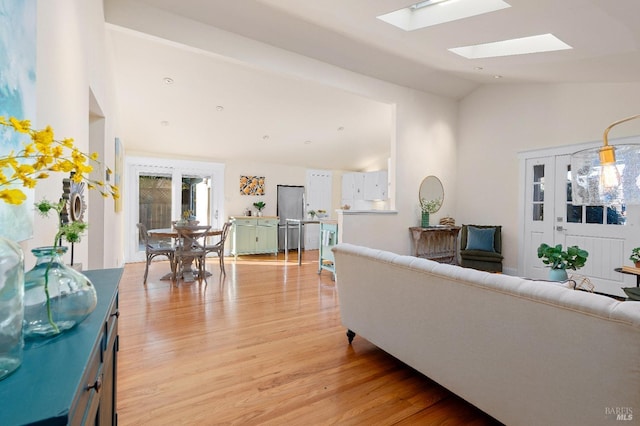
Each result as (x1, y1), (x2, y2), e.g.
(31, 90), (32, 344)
(105, 0), (640, 169)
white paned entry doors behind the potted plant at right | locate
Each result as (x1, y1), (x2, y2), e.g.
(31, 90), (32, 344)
(521, 154), (640, 296)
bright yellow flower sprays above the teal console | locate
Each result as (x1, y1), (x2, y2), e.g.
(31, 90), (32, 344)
(0, 116), (119, 204)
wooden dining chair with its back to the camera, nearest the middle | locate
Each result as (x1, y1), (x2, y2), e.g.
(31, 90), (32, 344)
(174, 225), (211, 280)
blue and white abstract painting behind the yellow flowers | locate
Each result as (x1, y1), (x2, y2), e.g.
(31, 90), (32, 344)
(0, 0), (37, 241)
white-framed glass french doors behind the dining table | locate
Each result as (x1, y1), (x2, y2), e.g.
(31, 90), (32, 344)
(125, 158), (225, 262)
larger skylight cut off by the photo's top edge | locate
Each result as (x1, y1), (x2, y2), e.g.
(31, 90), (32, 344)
(377, 0), (511, 31)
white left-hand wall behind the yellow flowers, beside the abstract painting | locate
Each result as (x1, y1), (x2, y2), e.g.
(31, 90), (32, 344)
(22, 0), (122, 269)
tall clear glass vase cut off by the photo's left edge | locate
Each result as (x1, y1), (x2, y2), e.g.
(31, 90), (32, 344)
(0, 237), (24, 380)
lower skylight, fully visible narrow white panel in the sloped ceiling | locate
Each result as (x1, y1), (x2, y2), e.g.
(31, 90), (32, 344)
(449, 34), (573, 59)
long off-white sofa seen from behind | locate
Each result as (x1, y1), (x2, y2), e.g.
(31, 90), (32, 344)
(333, 243), (640, 426)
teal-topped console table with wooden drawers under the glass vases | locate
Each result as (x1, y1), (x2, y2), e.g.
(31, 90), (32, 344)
(0, 269), (122, 426)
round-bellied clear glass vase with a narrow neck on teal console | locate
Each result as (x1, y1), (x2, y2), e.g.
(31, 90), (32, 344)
(24, 247), (98, 339)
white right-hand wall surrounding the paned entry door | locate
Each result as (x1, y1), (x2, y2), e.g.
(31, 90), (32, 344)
(458, 84), (640, 270)
